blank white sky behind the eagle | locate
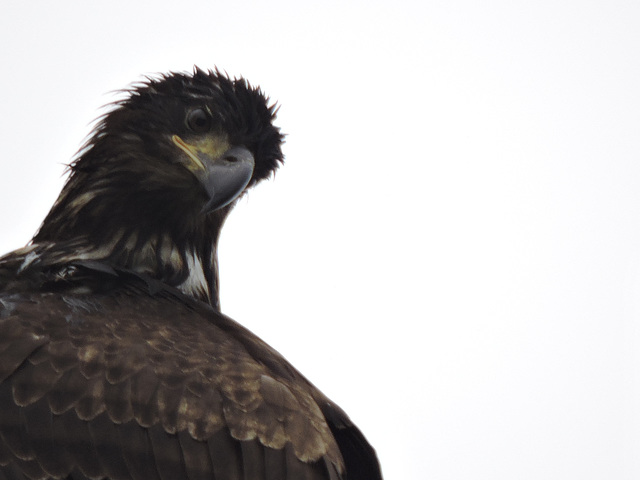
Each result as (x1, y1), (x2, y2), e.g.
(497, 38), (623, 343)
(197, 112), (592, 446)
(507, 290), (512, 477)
(0, 0), (640, 480)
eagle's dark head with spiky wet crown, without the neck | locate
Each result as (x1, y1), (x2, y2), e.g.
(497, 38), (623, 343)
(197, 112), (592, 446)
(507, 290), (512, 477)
(45, 69), (282, 233)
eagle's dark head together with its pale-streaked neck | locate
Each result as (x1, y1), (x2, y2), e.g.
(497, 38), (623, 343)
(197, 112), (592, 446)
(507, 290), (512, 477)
(27, 68), (283, 304)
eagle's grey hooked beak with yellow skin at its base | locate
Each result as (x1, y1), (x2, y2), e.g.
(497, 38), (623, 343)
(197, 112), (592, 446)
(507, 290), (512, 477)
(171, 135), (255, 213)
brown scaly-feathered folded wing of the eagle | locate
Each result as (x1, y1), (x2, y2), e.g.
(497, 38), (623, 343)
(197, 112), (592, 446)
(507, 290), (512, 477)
(0, 284), (344, 480)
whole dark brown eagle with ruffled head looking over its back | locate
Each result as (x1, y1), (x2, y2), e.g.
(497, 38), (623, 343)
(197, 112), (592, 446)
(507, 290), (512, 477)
(0, 69), (381, 480)
